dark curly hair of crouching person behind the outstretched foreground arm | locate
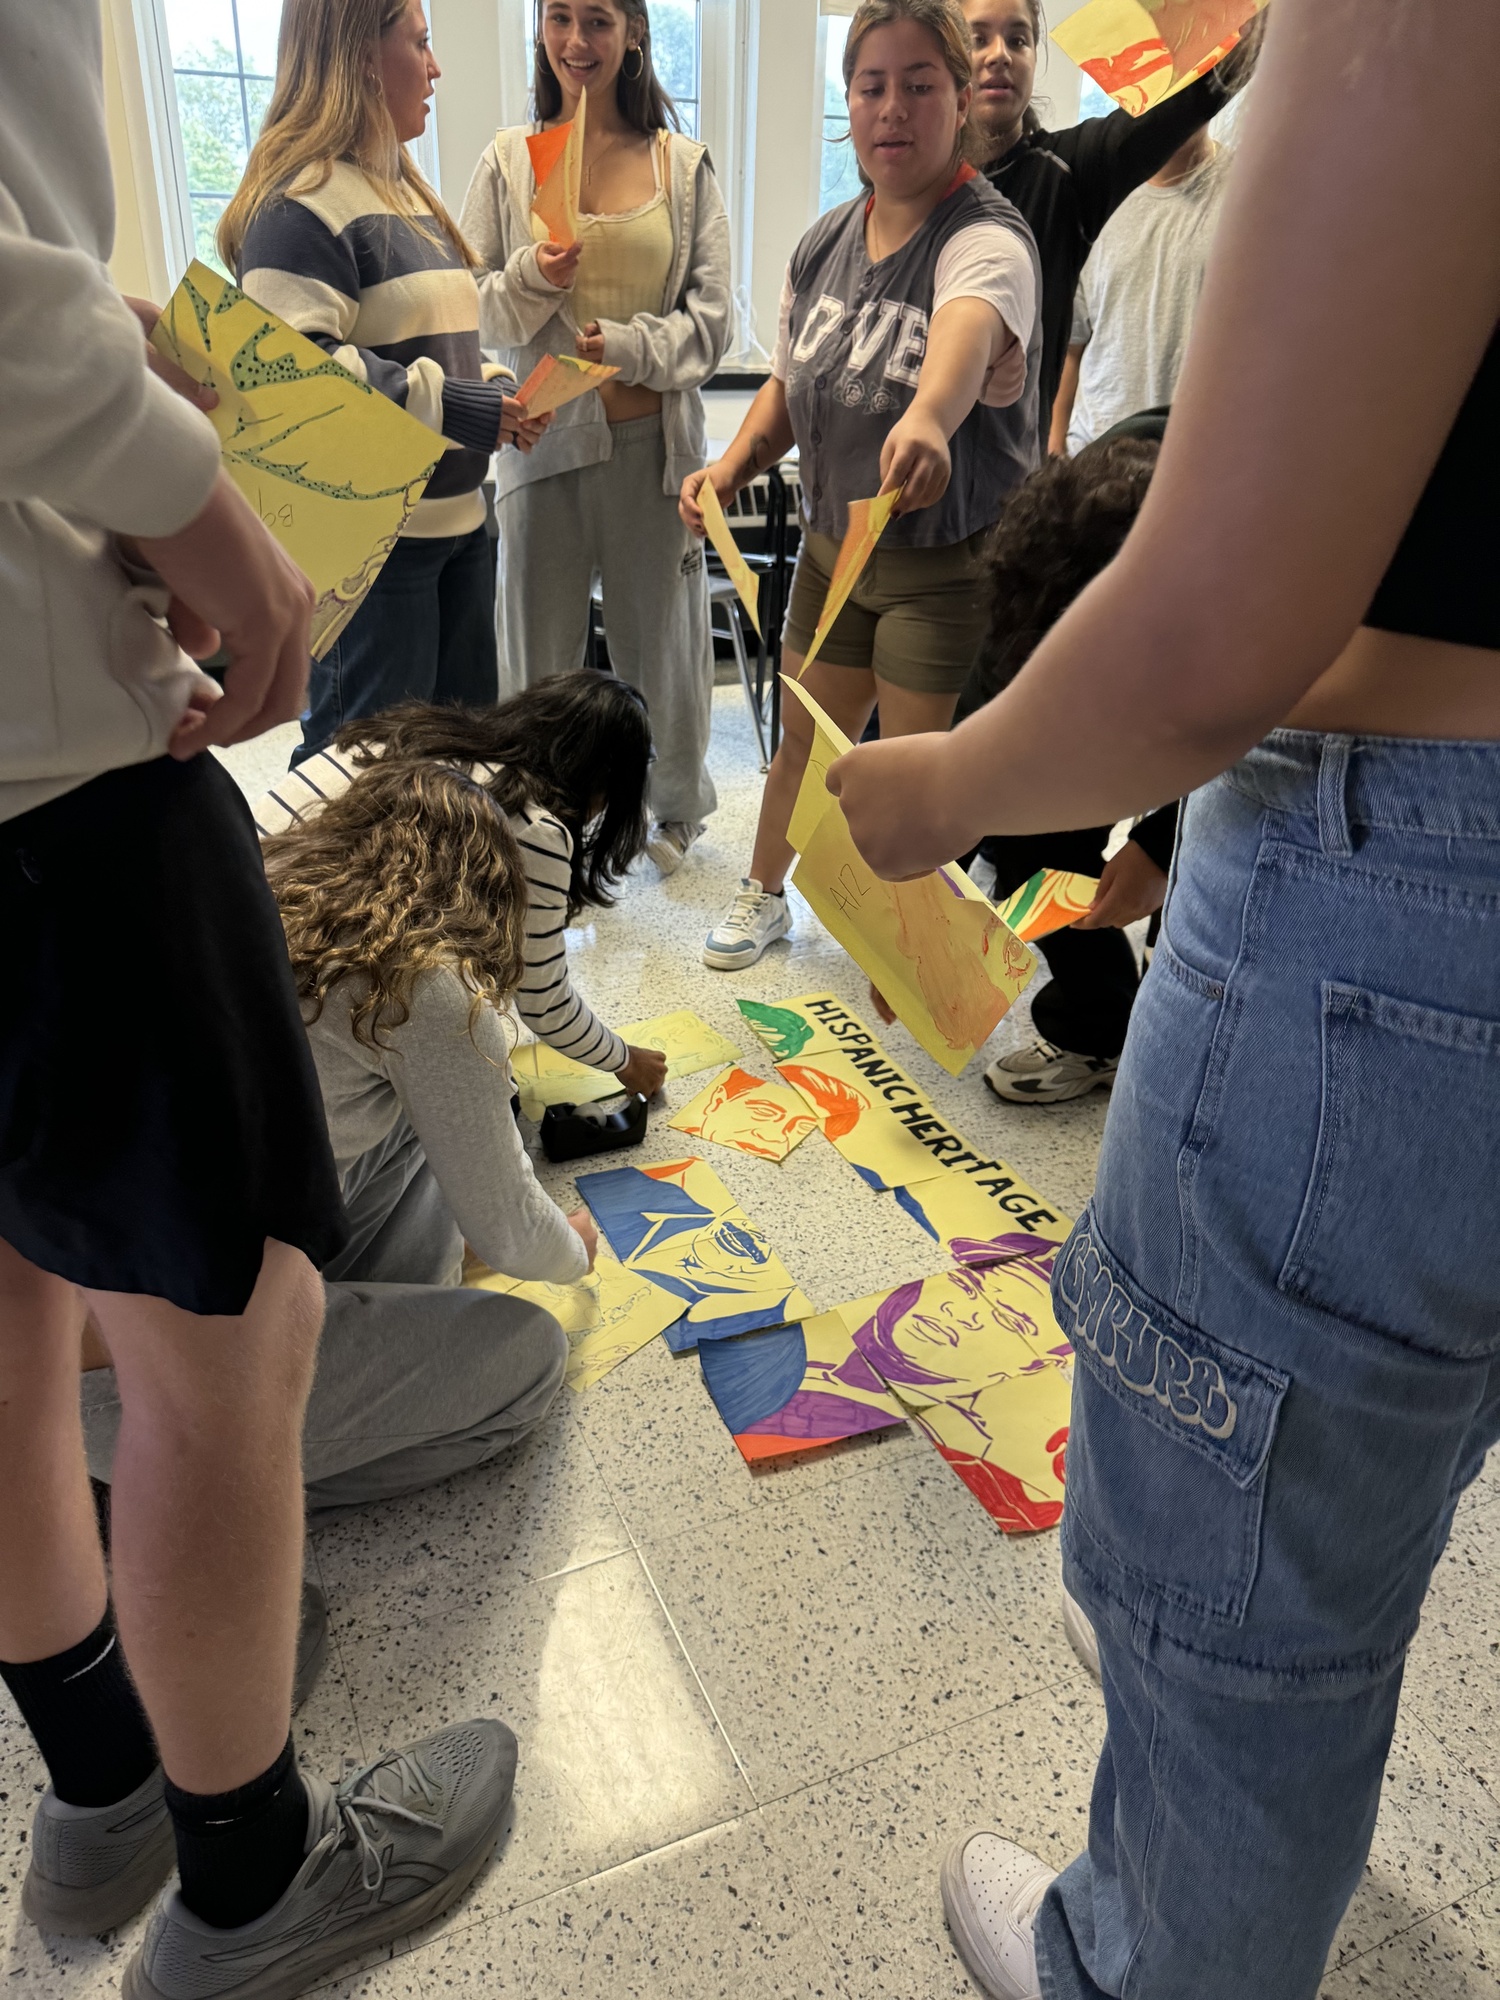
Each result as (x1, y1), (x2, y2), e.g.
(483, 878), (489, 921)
(956, 438), (1160, 720)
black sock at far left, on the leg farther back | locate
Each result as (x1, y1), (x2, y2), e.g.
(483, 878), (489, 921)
(0, 1606), (156, 1806)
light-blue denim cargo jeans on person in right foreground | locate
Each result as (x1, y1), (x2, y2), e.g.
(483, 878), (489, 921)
(1036, 730), (1500, 2000)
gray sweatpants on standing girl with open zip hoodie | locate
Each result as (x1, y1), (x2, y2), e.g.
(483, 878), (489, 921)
(496, 416), (718, 820)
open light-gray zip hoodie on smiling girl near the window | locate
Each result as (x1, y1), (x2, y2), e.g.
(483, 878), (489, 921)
(460, 126), (732, 496)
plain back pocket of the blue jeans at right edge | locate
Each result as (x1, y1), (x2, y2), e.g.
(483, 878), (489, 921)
(1278, 982), (1500, 1360)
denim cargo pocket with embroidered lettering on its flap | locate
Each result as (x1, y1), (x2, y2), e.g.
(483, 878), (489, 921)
(1052, 1214), (1288, 1624)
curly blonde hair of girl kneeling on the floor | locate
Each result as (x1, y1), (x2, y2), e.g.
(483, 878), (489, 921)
(262, 756), (526, 1048)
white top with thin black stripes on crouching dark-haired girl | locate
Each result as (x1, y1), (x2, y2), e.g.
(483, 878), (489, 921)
(254, 750), (626, 1070)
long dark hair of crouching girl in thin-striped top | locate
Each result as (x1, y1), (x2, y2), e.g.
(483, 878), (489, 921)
(334, 668), (652, 922)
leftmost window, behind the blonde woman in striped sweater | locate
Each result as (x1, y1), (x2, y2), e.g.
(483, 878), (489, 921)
(162, 0), (282, 270)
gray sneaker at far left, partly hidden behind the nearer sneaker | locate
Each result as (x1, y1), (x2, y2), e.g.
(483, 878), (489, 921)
(20, 1764), (178, 1938)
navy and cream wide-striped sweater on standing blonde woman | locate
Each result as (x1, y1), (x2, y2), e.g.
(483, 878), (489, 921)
(238, 160), (502, 536)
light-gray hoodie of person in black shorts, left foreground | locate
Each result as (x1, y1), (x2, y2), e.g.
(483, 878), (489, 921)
(0, 0), (218, 820)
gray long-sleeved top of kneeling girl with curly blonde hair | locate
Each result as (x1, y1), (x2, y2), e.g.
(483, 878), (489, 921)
(308, 970), (588, 1284)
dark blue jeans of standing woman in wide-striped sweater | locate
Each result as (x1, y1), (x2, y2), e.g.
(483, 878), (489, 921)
(292, 528), (500, 764)
